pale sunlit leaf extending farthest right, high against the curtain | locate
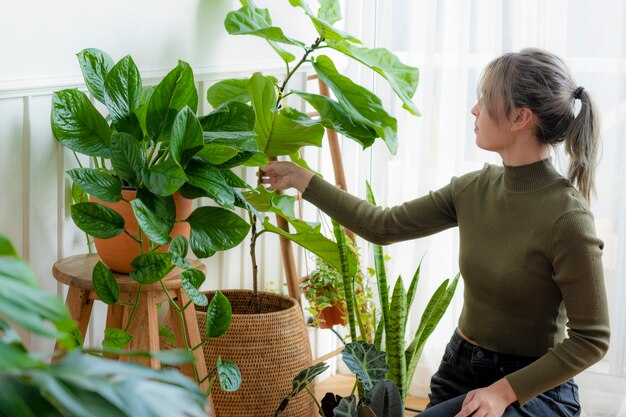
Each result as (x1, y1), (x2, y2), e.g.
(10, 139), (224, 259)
(328, 40), (420, 116)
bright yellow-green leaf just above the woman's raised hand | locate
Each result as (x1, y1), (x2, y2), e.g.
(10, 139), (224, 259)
(248, 74), (324, 157)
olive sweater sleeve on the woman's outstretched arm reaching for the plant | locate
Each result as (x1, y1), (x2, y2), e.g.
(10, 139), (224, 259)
(302, 172), (479, 245)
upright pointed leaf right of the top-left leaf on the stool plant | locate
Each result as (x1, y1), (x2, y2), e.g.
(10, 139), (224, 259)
(104, 55), (143, 139)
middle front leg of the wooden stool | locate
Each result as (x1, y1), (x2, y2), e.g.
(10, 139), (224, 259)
(124, 291), (161, 369)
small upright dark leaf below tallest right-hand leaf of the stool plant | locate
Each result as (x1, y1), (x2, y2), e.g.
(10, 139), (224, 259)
(170, 106), (204, 168)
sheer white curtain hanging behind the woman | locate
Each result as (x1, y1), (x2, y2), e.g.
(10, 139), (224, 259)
(336, 0), (626, 415)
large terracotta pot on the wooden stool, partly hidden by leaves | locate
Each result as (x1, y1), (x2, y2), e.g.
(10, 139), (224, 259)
(89, 189), (193, 274)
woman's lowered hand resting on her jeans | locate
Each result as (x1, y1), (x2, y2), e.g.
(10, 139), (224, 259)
(455, 378), (517, 417)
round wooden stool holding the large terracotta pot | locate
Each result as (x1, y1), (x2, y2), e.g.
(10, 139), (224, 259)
(52, 250), (208, 392)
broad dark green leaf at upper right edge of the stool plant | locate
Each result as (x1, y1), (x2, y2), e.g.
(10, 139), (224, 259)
(200, 100), (255, 132)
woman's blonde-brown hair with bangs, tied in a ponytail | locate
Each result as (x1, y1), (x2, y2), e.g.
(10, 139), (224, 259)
(478, 48), (600, 201)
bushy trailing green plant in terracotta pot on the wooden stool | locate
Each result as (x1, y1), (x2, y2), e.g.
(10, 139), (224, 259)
(51, 49), (252, 390)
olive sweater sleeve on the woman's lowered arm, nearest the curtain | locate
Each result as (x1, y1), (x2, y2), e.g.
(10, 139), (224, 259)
(506, 210), (610, 405)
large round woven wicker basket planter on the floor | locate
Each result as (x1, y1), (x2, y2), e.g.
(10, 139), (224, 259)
(163, 290), (317, 417)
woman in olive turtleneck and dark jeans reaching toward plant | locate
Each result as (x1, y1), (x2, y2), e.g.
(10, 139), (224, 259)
(262, 49), (609, 417)
